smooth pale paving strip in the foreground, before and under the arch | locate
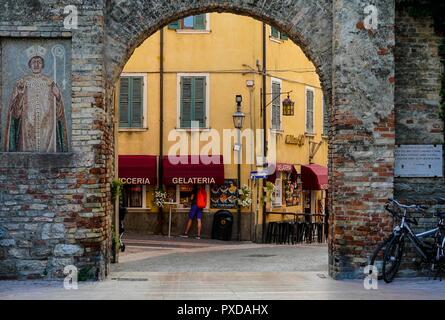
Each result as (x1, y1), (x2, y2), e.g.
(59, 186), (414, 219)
(0, 272), (445, 300)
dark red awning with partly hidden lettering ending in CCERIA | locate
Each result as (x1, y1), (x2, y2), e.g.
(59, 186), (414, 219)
(119, 156), (158, 185)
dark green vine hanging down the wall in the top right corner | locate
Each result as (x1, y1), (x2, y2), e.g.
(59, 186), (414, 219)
(398, 0), (445, 133)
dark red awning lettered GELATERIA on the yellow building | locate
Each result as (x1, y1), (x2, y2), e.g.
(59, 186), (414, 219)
(163, 156), (224, 185)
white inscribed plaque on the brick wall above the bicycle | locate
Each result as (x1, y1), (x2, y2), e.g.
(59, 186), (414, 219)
(395, 145), (443, 178)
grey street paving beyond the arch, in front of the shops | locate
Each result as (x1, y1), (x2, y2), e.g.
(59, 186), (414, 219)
(112, 237), (328, 272)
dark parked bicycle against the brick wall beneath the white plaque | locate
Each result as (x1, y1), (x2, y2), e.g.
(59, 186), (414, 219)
(371, 199), (445, 283)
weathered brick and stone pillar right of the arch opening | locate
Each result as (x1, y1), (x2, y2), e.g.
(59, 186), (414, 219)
(329, 0), (395, 279)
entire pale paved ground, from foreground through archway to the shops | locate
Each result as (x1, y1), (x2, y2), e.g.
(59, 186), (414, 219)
(0, 237), (445, 300)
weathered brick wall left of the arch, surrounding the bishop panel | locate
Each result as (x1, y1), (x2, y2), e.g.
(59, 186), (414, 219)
(0, 0), (113, 279)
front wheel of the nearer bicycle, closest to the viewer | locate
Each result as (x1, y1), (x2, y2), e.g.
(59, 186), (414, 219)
(382, 235), (405, 283)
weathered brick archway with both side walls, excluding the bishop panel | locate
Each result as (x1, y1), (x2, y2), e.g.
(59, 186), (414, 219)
(0, 0), (395, 278)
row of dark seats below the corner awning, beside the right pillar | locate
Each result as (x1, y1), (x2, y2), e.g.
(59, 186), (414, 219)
(266, 221), (326, 245)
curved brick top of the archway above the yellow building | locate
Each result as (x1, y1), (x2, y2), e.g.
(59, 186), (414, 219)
(105, 0), (332, 97)
